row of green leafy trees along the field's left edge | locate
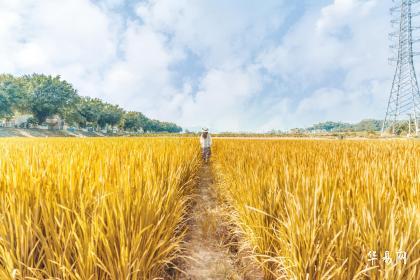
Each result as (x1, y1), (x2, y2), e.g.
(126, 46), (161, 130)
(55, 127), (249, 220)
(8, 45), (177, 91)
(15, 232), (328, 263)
(0, 74), (182, 133)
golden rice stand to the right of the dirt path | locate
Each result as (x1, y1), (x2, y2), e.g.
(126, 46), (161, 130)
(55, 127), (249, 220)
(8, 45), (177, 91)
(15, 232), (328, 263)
(213, 140), (420, 280)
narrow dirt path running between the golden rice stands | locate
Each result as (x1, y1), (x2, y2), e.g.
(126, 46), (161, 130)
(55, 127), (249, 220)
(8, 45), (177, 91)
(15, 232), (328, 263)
(179, 164), (241, 280)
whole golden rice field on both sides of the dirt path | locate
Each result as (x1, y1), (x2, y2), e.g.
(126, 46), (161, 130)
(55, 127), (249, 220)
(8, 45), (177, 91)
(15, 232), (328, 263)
(0, 138), (420, 280)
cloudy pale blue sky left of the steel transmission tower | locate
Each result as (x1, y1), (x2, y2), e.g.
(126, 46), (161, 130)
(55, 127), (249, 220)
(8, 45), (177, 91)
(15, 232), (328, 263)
(0, 0), (406, 131)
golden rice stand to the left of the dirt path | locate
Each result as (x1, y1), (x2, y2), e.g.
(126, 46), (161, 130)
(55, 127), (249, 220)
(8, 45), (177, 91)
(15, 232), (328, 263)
(0, 139), (199, 280)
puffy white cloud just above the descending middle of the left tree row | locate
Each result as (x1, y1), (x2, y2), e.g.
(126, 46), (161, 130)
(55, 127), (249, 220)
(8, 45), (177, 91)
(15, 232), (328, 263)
(104, 22), (180, 117)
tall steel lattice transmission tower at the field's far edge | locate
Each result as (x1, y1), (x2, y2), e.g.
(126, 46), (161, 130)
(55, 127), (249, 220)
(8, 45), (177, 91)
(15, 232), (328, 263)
(382, 0), (420, 135)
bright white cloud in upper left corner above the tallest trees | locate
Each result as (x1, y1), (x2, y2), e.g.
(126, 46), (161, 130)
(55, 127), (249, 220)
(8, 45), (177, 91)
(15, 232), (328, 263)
(0, 0), (118, 104)
